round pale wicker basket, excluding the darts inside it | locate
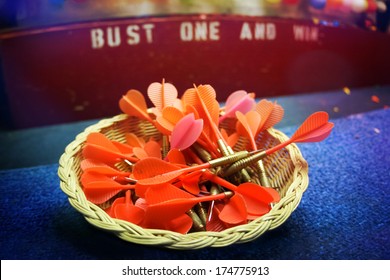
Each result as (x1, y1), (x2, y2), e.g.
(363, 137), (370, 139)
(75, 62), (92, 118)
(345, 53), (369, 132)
(58, 114), (308, 250)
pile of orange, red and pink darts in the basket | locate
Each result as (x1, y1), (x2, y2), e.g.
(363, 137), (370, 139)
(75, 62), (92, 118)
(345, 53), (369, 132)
(81, 80), (333, 234)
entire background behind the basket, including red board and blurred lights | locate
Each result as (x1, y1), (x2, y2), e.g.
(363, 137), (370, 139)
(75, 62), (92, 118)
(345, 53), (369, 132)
(0, 0), (390, 169)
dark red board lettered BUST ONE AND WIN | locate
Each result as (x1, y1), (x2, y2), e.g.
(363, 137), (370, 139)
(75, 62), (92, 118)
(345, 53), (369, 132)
(0, 15), (390, 128)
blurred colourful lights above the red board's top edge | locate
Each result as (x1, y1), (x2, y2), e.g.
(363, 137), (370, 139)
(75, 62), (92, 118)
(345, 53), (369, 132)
(0, 0), (389, 32)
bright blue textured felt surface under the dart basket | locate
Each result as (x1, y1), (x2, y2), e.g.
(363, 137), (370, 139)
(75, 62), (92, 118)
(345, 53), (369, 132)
(0, 110), (390, 259)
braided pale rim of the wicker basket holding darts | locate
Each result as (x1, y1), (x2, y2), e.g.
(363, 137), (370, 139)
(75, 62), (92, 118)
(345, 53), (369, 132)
(58, 114), (309, 250)
